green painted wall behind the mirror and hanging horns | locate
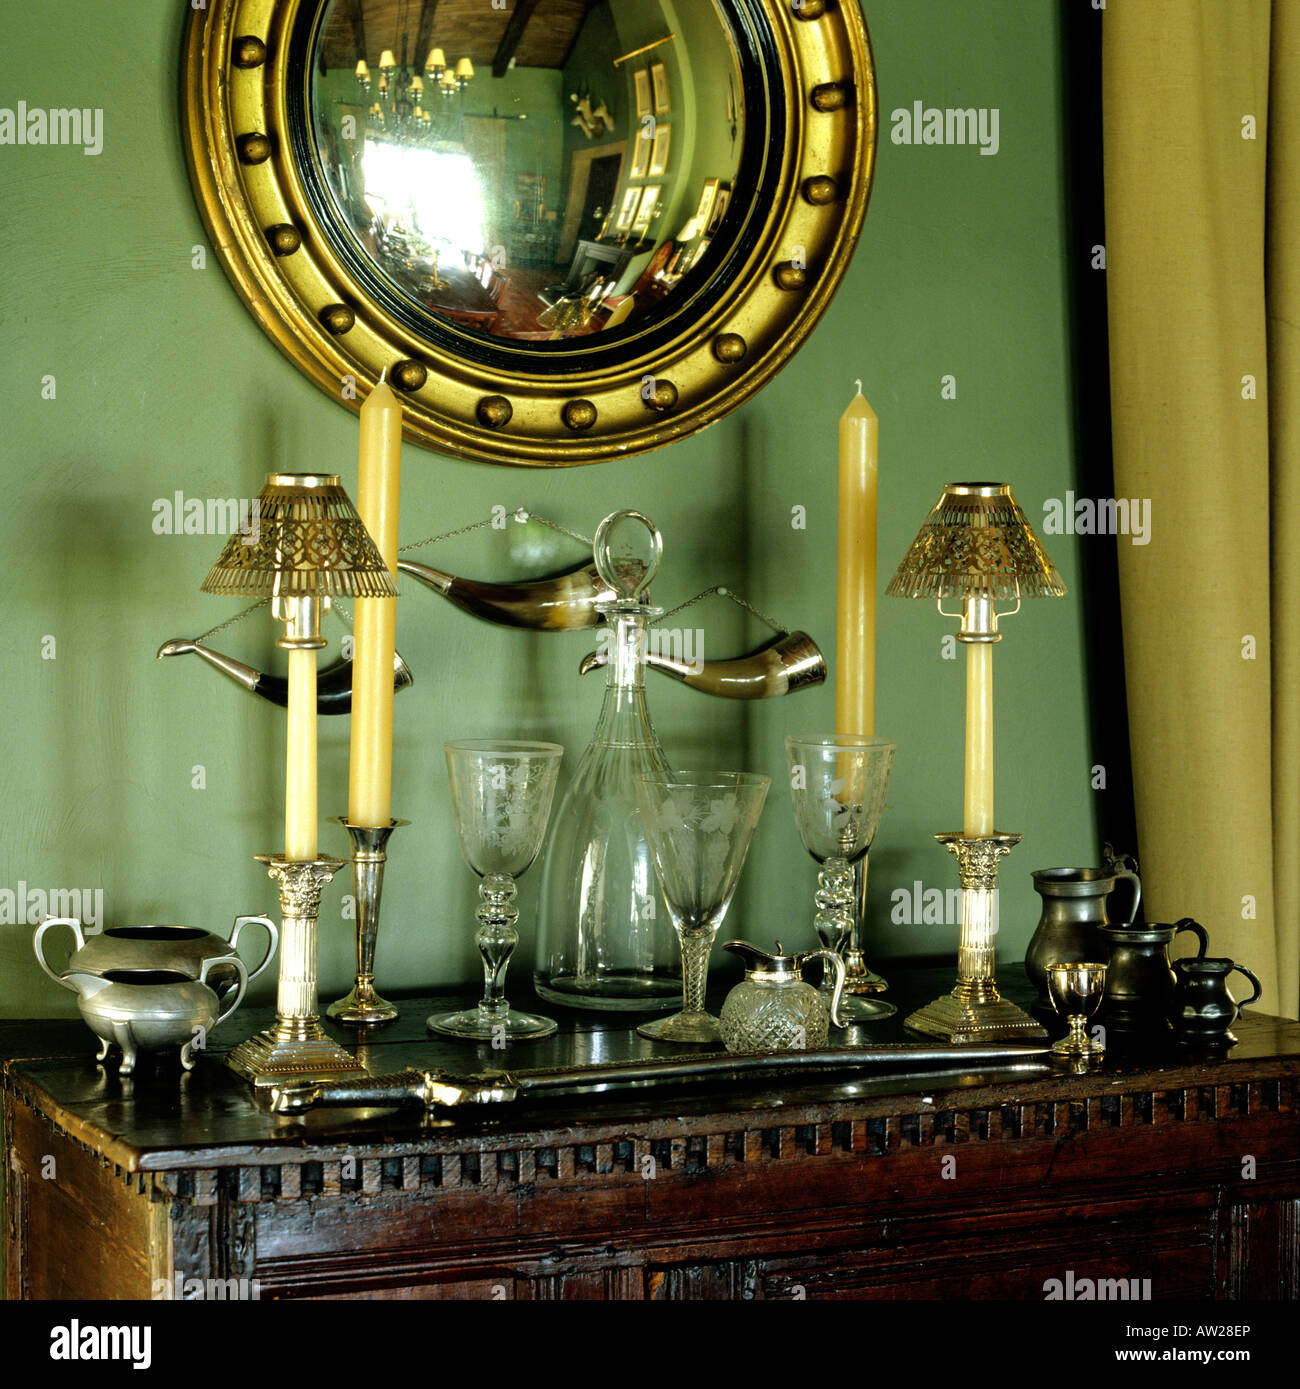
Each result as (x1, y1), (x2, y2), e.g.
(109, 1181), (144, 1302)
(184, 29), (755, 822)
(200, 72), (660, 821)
(0, 0), (1097, 1017)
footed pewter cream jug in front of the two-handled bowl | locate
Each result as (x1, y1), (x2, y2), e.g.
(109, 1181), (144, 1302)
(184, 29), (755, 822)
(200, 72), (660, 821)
(56, 956), (249, 1075)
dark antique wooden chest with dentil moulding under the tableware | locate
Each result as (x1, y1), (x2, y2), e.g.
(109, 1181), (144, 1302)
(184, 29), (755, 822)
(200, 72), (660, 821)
(0, 971), (1300, 1300)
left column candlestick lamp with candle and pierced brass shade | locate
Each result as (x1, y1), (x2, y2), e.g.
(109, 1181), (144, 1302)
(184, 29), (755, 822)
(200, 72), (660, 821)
(203, 474), (397, 1089)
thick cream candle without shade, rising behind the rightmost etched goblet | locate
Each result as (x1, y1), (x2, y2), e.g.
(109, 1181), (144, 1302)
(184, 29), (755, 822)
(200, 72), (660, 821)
(835, 382), (881, 738)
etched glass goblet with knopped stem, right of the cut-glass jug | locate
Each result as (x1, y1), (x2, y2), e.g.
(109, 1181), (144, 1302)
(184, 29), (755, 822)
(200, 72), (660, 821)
(786, 733), (899, 1022)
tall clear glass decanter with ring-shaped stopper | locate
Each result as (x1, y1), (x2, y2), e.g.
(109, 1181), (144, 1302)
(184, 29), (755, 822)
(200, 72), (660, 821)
(533, 511), (682, 1011)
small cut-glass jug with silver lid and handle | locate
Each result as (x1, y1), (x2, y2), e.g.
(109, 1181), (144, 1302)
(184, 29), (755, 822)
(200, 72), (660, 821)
(718, 940), (847, 1051)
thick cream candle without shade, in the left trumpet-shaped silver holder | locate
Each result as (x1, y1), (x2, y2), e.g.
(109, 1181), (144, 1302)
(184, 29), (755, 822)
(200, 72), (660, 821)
(347, 381), (401, 828)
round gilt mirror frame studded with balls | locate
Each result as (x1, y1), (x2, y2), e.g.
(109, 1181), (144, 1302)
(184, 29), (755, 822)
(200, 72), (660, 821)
(182, 0), (878, 467)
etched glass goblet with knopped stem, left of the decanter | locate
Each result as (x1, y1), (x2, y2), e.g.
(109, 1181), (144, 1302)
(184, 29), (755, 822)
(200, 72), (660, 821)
(426, 742), (564, 1042)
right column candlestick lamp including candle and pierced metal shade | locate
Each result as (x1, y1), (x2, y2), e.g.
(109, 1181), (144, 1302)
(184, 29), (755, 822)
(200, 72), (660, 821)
(885, 482), (1065, 1043)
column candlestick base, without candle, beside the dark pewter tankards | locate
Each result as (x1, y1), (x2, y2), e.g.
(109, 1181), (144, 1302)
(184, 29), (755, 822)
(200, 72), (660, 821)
(907, 835), (1047, 1043)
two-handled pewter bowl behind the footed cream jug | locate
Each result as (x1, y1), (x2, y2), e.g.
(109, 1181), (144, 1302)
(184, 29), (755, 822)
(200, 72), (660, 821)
(32, 917), (279, 983)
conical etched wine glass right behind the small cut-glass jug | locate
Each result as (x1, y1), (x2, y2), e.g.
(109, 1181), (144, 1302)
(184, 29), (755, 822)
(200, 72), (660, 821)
(636, 772), (771, 1042)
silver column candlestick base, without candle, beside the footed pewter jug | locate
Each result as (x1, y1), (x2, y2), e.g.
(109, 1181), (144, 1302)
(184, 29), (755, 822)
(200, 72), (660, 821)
(218, 854), (365, 1089)
